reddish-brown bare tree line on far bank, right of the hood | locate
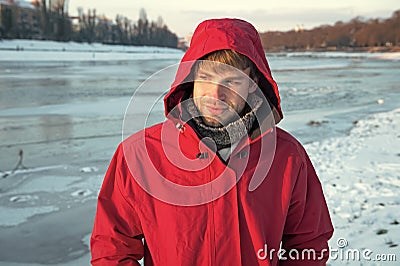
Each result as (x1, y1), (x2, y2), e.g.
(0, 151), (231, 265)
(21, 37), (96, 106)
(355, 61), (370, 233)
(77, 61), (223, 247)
(260, 10), (400, 51)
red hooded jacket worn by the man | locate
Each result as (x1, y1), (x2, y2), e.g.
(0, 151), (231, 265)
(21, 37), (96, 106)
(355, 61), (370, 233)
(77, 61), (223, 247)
(91, 19), (333, 266)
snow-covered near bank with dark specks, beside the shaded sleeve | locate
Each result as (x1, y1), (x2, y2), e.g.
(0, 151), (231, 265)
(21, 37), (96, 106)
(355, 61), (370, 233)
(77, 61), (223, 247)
(306, 109), (400, 265)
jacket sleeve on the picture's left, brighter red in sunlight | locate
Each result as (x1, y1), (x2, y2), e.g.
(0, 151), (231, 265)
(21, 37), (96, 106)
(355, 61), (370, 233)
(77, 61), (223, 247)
(90, 145), (144, 266)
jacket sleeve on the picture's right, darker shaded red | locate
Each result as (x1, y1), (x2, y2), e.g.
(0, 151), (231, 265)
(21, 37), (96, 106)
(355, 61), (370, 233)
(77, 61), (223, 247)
(279, 150), (333, 266)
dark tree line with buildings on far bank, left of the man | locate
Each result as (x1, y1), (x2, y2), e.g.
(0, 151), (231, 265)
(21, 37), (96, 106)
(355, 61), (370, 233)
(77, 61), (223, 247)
(0, 0), (178, 48)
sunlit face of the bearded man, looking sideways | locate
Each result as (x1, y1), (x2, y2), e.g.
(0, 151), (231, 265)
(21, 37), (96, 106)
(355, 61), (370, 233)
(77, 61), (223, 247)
(193, 63), (256, 127)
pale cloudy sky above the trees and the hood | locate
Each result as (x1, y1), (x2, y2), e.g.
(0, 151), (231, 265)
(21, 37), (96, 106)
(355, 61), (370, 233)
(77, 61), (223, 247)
(69, 0), (400, 37)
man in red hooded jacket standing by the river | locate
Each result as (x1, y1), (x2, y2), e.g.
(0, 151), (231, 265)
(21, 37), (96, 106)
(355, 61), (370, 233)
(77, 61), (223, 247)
(91, 19), (333, 265)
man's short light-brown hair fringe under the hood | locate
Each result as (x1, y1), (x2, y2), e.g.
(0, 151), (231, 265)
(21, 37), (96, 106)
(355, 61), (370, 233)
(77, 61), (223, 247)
(197, 49), (258, 78)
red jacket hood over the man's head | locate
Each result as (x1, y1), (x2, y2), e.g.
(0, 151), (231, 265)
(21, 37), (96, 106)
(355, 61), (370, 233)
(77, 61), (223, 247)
(164, 18), (283, 123)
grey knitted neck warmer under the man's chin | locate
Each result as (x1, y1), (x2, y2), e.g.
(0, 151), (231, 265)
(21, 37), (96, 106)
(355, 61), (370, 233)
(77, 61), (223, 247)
(185, 93), (263, 150)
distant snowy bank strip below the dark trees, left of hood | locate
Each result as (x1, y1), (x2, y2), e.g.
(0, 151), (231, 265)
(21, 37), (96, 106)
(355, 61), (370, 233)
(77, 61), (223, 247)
(0, 40), (183, 61)
